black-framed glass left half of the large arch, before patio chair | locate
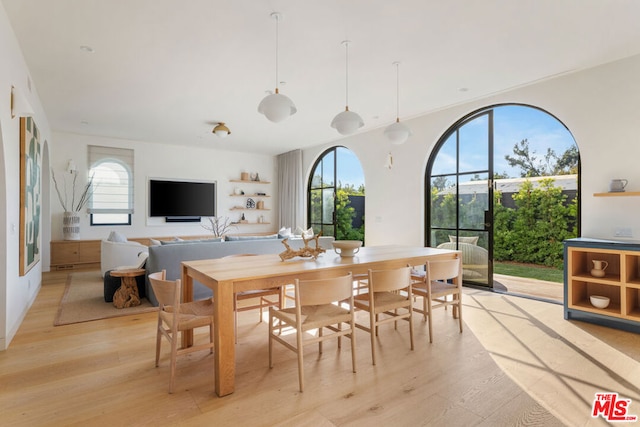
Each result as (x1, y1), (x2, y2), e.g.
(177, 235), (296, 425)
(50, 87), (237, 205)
(426, 110), (493, 287)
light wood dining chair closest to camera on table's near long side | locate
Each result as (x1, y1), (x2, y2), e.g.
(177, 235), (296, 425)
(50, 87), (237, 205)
(269, 273), (356, 392)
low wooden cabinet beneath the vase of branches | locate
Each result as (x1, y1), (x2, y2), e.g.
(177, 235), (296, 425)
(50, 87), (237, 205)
(51, 240), (100, 270)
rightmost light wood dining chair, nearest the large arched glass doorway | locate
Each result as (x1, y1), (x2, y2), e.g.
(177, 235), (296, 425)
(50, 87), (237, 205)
(411, 255), (462, 342)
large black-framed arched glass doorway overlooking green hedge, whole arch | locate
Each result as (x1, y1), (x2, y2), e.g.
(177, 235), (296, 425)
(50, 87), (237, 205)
(425, 105), (579, 298)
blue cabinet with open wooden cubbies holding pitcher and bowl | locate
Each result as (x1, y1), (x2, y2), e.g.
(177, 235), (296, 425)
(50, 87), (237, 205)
(564, 238), (640, 332)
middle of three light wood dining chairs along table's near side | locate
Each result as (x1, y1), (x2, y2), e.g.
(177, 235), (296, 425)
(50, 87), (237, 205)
(354, 267), (413, 365)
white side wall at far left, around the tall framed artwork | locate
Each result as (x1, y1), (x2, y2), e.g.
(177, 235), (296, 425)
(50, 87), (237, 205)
(0, 3), (50, 350)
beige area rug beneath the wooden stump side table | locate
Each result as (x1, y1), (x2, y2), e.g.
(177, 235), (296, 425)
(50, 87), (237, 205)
(53, 271), (158, 326)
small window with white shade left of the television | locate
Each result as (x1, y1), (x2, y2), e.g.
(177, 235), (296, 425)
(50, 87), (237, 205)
(88, 146), (133, 225)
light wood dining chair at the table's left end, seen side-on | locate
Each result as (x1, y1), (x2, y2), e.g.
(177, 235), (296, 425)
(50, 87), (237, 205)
(149, 270), (214, 393)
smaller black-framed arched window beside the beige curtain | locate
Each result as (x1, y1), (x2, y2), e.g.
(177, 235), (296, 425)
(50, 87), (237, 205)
(307, 147), (365, 241)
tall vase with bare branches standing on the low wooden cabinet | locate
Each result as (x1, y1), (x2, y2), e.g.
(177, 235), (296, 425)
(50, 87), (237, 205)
(51, 160), (94, 240)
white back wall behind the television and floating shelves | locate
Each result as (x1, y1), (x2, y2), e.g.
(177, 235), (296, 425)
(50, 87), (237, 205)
(50, 132), (278, 246)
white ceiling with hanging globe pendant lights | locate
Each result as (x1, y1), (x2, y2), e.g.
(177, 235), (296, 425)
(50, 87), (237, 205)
(2, 0), (640, 154)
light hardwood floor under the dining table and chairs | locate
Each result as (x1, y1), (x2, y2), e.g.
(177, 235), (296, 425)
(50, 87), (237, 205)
(0, 273), (640, 427)
